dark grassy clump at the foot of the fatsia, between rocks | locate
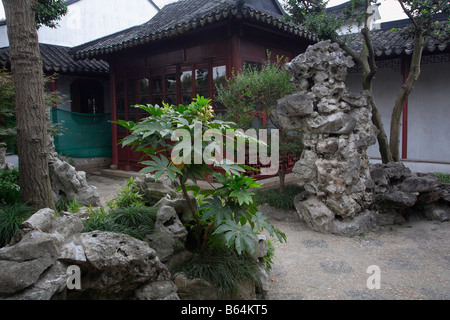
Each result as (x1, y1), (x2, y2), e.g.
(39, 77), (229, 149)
(171, 249), (261, 298)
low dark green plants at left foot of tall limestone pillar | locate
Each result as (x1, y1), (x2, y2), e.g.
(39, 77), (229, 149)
(254, 184), (304, 210)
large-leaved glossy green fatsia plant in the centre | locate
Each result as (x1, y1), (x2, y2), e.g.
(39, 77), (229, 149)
(115, 95), (286, 254)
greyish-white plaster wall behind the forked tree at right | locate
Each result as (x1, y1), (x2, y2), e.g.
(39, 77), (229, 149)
(347, 57), (450, 172)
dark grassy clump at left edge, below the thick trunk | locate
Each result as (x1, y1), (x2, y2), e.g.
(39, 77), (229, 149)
(0, 202), (35, 247)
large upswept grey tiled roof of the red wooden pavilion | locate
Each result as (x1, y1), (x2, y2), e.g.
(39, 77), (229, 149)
(71, 0), (315, 59)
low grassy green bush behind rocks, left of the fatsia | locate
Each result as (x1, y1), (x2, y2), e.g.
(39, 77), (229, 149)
(83, 205), (158, 240)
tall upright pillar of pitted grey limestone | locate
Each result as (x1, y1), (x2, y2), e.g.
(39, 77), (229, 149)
(275, 41), (377, 235)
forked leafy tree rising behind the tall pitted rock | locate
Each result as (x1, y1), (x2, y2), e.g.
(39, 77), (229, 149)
(285, 0), (450, 163)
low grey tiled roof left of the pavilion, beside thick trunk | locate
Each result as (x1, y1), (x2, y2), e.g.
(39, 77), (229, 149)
(0, 44), (109, 74)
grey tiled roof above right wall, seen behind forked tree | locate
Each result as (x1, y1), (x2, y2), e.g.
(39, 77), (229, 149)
(350, 16), (450, 58)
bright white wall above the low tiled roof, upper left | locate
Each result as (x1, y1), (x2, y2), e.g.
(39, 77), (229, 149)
(0, 0), (157, 47)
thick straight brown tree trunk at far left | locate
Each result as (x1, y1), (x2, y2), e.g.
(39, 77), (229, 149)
(3, 0), (55, 209)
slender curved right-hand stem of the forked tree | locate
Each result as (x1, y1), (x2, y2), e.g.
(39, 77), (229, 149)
(390, 31), (424, 161)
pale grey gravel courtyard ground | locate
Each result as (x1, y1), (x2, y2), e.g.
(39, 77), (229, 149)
(88, 175), (450, 300)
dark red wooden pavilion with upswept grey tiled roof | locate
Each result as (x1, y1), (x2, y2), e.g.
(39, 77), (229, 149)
(72, 0), (316, 170)
